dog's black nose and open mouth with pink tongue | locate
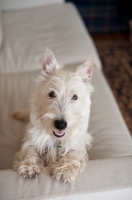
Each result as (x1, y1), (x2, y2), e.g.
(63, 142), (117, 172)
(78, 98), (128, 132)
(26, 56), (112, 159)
(53, 119), (67, 138)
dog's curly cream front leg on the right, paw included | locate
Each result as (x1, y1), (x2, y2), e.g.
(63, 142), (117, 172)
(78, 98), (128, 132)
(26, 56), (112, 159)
(51, 151), (87, 183)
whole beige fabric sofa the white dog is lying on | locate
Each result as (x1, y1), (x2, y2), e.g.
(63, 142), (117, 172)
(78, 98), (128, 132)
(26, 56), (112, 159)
(0, 3), (132, 200)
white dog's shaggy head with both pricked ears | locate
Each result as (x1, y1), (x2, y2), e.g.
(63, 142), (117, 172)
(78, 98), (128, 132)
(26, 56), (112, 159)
(31, 50), (93, 138)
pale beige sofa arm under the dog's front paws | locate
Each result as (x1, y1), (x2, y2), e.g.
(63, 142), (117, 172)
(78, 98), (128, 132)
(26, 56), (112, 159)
(0, 156), (132, 200)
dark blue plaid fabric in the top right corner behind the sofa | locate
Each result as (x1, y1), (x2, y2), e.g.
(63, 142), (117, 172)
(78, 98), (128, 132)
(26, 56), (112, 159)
(66, 0), (132, 34)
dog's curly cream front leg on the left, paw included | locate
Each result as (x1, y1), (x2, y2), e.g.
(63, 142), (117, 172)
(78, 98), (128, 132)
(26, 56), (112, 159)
(13, 149), (44, 178)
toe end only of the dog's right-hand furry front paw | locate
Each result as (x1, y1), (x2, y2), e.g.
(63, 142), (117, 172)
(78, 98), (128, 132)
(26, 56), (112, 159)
(51, 165), (78, 183)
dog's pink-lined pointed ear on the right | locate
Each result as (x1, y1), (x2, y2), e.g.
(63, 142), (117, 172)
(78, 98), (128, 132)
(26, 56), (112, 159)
(77, 59), (93, 83)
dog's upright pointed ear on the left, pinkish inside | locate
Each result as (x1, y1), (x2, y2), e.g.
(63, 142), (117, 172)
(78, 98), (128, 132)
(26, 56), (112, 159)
(42, 50), (60, 74)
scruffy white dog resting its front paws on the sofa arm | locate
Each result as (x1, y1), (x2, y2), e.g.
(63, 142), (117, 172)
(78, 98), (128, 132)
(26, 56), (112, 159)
(14, 50), (93, 182)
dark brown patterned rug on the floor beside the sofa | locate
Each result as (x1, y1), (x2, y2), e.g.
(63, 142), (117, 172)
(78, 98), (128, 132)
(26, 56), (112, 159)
(95, 41), (132, 135)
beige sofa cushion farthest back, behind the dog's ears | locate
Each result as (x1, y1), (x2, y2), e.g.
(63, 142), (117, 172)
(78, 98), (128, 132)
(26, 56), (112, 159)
(0, 4), (101, 74)
